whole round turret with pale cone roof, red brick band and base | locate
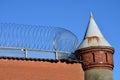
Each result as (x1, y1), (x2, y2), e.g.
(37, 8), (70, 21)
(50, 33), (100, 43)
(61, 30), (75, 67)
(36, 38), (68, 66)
(75, 14), (114, 80)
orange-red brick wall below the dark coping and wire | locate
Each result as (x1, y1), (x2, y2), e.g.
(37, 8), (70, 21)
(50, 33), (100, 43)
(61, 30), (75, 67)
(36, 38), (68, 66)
(0, 59), (84, 80)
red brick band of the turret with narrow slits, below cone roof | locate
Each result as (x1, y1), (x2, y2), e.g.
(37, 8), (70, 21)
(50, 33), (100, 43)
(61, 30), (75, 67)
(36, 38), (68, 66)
(75, 46), (114, 70)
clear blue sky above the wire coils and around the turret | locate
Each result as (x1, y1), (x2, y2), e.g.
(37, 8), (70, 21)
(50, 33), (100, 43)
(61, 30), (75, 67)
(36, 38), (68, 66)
(0, 0), (120, 80)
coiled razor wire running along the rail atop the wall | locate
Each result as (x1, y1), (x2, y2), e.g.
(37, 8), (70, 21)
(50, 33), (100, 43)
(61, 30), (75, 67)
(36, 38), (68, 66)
(0, 23), (78, 58)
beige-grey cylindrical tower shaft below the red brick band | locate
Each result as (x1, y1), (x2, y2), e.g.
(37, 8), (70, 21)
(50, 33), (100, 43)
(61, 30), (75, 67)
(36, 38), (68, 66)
(85, 69), (113, 80)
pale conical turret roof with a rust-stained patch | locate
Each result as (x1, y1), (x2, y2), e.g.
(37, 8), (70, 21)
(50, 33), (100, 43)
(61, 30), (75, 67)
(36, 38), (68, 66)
(78, 13), (111, 49)
